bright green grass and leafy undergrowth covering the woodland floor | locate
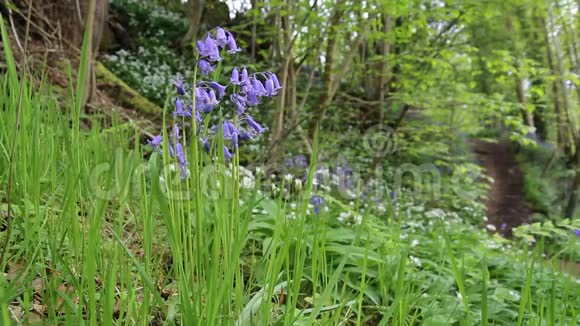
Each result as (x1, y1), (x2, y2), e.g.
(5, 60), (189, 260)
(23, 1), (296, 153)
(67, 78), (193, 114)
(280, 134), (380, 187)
(0, 11), (580, 325)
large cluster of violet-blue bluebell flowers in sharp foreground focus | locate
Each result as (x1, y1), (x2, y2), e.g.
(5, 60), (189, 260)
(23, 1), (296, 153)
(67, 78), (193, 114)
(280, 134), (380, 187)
(149, 27), (282, 178)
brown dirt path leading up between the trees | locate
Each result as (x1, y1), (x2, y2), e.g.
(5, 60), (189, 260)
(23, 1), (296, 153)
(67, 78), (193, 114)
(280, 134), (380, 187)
(472, 139), (530, 236)
